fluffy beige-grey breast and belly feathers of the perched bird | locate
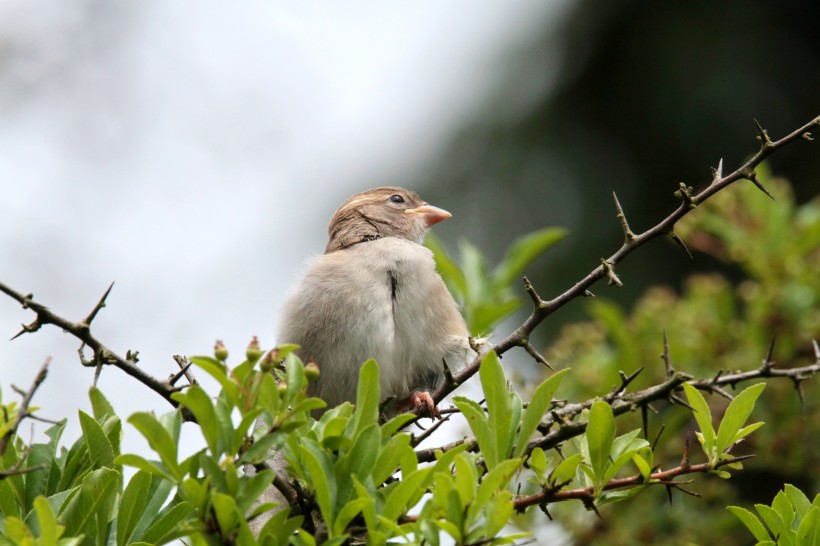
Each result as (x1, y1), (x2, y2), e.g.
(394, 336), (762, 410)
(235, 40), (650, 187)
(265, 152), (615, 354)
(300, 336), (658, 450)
(280, 237), (469, 396)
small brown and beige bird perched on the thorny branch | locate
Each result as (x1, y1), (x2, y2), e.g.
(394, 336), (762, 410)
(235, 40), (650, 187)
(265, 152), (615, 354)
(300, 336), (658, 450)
(277, 187), (473, 417)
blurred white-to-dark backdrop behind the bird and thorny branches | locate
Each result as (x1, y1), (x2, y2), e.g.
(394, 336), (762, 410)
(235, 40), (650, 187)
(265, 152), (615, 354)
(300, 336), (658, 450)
(0, 0), (820, 540)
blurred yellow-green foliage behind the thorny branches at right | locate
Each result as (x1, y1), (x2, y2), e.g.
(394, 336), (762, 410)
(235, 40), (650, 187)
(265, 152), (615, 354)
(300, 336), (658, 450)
(544, 167), (820, 545)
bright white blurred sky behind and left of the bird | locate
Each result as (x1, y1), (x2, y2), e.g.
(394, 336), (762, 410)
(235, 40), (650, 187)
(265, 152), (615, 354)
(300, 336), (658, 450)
(0, 0), (568, 536)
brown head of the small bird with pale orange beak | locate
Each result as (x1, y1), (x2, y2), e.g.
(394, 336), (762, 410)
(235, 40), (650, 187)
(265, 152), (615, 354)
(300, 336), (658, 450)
(325, 186), (452, 253)
